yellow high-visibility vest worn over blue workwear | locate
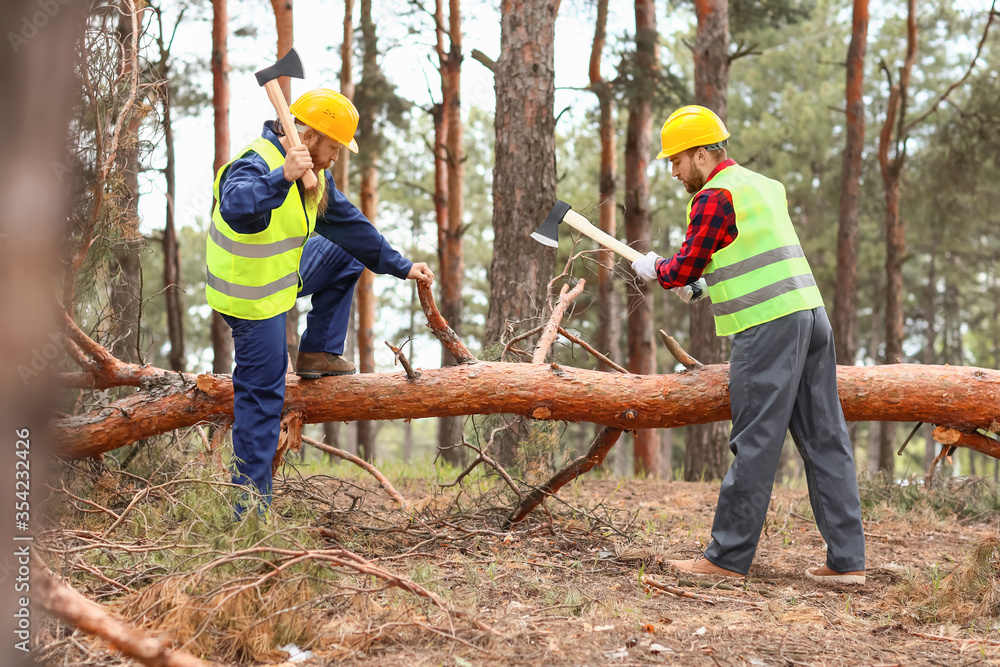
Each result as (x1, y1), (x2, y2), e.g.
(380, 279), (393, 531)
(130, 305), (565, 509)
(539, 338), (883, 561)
(205, 137), (326, 320)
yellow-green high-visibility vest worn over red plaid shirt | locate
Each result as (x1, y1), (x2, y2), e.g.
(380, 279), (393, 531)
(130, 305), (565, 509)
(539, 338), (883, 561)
(700, 165), (823, 336)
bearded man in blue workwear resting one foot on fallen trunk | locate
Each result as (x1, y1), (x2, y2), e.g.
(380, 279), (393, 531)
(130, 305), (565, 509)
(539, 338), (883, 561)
(206, 89), (434, 514)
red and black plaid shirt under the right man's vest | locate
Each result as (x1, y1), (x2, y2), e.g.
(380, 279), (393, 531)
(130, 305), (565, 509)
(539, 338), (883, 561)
(656, 158), (737, 289)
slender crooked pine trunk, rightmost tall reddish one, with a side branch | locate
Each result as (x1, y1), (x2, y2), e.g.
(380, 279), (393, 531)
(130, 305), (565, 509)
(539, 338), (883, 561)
(878, 0), (917, 477)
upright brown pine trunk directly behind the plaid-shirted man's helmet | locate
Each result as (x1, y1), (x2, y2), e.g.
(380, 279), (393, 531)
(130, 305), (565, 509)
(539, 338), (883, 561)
(684, 0), (729, 481)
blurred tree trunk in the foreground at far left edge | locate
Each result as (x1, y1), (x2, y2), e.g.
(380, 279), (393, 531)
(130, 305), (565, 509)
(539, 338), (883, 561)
(0, 0), (85, 667)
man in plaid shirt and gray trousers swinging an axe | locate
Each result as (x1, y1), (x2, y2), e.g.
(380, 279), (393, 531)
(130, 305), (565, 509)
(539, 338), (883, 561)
(632, 105), (865, 584)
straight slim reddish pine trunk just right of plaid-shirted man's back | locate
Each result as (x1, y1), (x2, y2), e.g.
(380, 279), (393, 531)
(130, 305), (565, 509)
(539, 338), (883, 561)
(833, 0), (868, 365)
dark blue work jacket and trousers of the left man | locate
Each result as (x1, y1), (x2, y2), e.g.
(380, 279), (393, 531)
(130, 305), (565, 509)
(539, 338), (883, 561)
(218, 122), (413, 513)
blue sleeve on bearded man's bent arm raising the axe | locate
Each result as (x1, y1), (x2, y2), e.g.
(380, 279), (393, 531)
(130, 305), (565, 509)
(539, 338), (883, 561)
(219, 153), (292, 234)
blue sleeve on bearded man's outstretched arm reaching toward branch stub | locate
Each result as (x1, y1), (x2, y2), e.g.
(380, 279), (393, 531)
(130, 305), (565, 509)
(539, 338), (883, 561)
(316, 172), (413, 279)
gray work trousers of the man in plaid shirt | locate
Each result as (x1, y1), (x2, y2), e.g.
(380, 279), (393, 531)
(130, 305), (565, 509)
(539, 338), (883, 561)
(705, 308), (865, 574)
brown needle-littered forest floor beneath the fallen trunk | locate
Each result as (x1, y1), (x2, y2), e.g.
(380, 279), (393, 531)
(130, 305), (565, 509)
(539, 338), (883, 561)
(35, 456), (1000, 667)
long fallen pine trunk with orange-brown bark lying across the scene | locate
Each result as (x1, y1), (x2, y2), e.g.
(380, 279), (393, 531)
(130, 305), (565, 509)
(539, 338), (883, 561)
(55, 362), (1000, 457)
